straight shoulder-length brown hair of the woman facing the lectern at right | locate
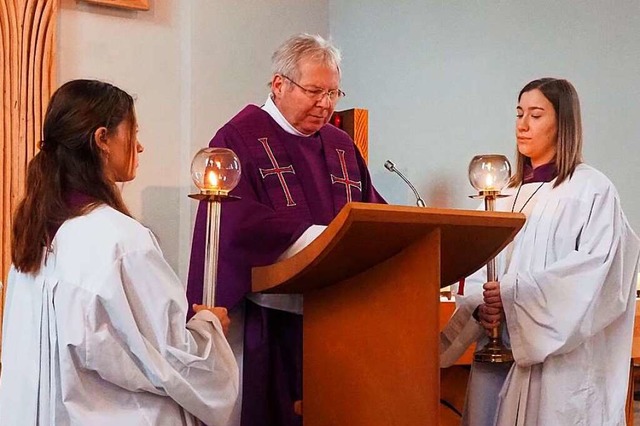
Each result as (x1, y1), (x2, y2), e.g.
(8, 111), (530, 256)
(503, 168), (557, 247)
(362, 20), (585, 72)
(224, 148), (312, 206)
(510, 78), (582, 187)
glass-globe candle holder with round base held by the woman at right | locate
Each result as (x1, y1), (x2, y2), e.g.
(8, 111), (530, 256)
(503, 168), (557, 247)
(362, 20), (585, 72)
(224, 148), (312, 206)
(469, 154), (513, 363)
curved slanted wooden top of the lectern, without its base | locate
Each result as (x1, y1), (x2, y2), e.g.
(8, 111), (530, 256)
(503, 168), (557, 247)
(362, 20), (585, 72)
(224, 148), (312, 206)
(252, 203), (525, 293)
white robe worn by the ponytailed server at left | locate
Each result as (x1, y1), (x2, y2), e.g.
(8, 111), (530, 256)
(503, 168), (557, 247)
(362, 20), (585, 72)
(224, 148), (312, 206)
(0, 207), (239, 426)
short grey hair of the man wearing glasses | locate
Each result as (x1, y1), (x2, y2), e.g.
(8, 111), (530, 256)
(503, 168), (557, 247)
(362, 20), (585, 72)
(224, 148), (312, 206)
(271, 34), (342, 81)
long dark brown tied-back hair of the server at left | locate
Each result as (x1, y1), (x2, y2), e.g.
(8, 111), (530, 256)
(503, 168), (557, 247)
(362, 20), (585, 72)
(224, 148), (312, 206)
(11, 80), (136, 273)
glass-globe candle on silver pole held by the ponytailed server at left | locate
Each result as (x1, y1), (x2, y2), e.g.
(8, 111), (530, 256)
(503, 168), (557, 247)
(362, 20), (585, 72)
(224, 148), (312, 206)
(189, 148), (242, 306)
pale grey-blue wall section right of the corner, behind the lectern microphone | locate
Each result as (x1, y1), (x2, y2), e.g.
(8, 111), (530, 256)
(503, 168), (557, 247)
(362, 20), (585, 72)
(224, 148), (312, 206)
(330, 0), (640, 232)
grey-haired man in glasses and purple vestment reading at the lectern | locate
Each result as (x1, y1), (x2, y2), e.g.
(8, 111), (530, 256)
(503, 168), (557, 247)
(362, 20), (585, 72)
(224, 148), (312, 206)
(188, 34), (385, 426)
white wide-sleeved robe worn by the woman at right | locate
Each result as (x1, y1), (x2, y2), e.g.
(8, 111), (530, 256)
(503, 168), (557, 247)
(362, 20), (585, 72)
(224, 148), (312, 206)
(442, 164), (640, 426)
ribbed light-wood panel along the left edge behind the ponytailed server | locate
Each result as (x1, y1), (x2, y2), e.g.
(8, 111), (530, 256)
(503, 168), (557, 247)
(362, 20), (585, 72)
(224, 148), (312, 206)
(0, 0), (59, 350)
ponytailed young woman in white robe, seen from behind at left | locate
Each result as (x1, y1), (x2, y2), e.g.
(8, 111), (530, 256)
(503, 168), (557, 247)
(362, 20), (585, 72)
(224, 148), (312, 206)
(0, 80), (239, 426)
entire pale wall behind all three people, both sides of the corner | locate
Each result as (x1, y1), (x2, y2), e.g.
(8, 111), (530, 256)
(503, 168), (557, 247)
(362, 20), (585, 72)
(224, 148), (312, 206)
(58, 0), (640, 278)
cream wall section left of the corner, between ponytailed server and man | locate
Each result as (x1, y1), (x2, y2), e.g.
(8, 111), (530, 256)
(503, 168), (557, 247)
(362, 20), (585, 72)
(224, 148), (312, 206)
(58, 0), (328, 279)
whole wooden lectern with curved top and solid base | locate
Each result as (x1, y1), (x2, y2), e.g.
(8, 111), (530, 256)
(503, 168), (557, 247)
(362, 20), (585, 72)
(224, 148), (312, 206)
(253, 203), (525, 426)
